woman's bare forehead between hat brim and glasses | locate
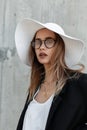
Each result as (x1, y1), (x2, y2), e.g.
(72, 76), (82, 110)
(36, 28), (55, 39)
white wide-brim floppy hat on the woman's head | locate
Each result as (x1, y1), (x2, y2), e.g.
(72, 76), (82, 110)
(15, 19), (84, 69)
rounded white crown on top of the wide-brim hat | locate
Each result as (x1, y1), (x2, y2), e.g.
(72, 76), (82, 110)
(45, 23), (65, 35)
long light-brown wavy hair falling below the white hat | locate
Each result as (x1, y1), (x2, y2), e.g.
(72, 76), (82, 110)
(29, 28), (84, 99)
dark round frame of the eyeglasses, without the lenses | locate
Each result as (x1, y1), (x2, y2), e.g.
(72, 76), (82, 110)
(31, 37), (57, 49)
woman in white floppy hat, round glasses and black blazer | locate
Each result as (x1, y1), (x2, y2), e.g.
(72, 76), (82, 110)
(15, 19), (87, 130)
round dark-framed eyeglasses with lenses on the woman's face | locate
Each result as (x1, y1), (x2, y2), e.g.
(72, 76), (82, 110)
(31, 37), (56, 49)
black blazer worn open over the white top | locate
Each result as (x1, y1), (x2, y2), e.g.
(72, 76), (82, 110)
(16, 74), (87, 130)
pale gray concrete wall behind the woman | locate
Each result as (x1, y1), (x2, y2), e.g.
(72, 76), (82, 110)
(0, 0), (87, 130)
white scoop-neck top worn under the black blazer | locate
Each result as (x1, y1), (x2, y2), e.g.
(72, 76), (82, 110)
(23, 89), (54, 130)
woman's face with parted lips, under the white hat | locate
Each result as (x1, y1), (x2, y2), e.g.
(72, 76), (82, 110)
(35, 29), (56, 66)
